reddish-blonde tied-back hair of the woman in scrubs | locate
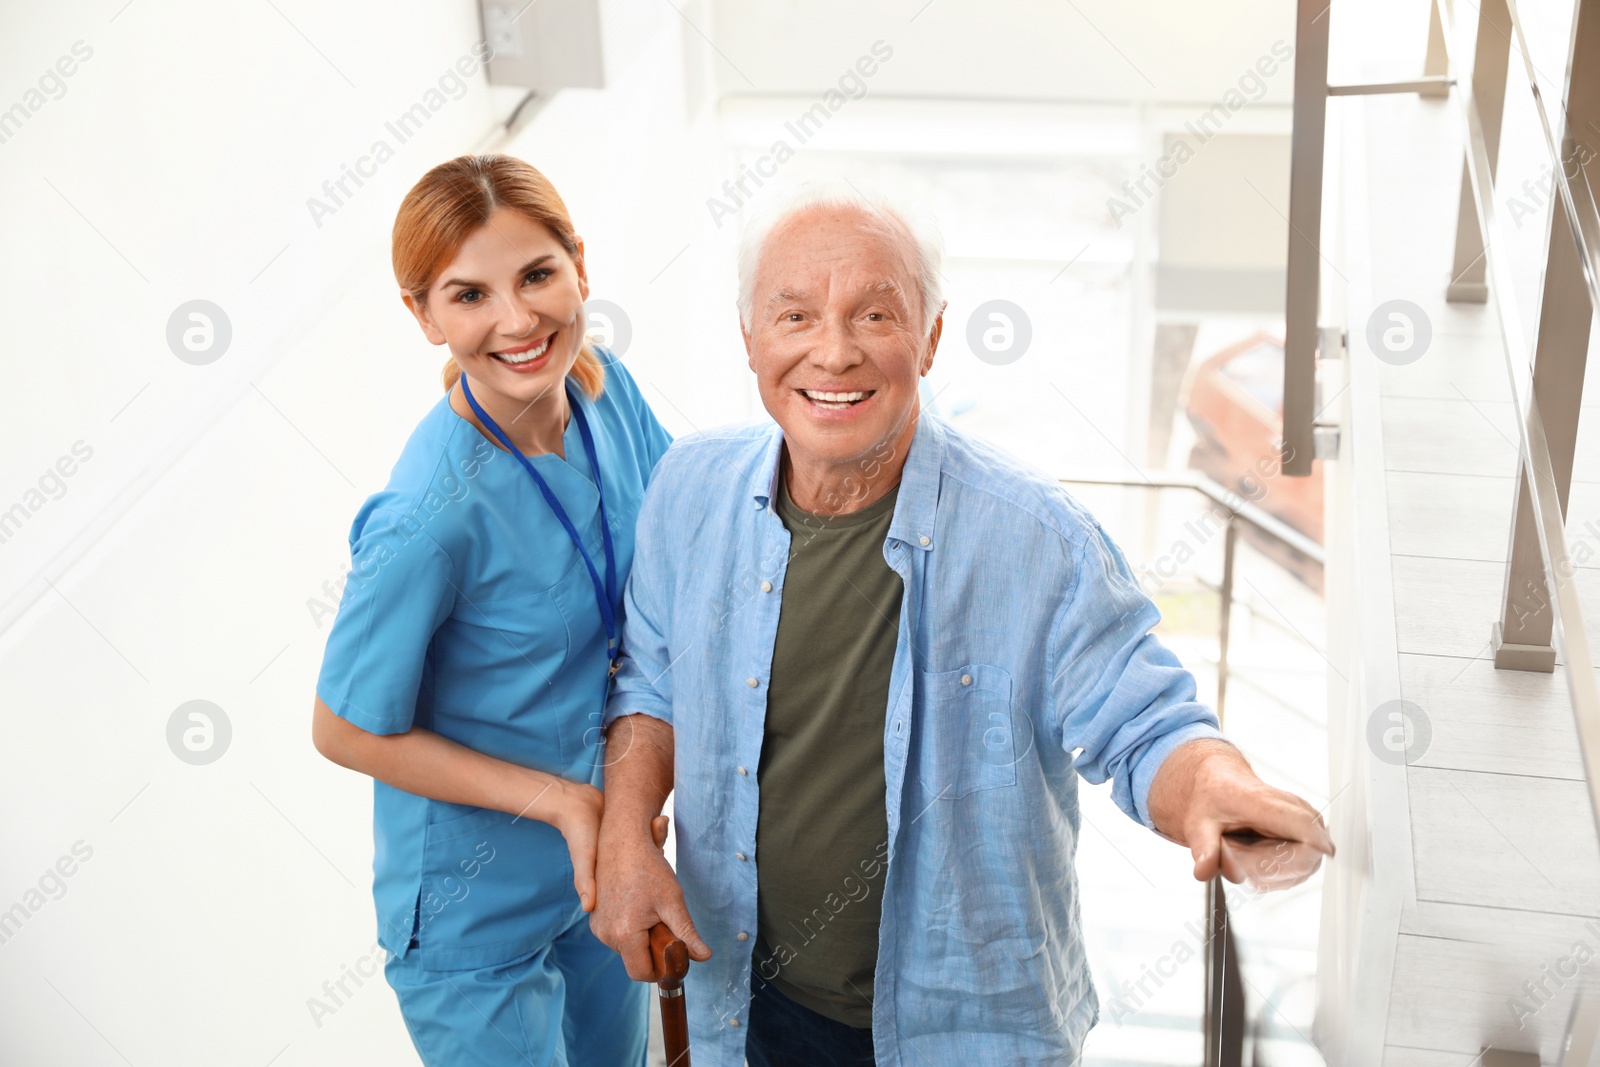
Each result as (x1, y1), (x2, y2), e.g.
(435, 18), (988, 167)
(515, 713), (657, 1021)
(390, 154), (605, 400)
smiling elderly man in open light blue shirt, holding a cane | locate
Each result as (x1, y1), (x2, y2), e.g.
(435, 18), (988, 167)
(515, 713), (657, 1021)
(592, 192), (1333, 1067)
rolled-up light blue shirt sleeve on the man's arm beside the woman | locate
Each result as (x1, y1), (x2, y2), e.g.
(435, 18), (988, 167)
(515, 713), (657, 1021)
(603, 464), (674, 726)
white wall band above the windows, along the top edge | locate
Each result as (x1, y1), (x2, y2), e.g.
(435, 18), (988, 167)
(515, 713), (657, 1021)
(707, 0), (1294, 104)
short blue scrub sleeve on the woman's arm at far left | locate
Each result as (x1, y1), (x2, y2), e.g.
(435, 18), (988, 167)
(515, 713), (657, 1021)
(317, 507), (456, 734)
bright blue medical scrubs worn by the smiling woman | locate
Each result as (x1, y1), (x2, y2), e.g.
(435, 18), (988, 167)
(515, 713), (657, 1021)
(317, 349), (670, 1067)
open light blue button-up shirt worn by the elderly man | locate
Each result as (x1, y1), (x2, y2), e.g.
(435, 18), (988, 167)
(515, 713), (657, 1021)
(605, 404), (1221, 1067)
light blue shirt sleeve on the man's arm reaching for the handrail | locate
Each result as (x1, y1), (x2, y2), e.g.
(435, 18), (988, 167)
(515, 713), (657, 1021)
(1050, 520), (1222, 829)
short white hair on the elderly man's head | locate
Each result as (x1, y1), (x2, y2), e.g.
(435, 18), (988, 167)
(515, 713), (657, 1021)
(739, 181), (944, 336)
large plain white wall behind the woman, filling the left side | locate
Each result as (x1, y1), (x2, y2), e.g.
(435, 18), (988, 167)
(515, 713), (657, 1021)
(0, 0), (731, 1067)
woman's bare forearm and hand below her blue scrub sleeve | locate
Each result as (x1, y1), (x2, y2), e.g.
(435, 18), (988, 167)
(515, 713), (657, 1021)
(310, 697), (602, 912)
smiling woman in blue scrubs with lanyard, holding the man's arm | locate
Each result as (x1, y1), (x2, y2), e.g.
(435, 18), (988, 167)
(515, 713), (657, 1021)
(312, 155), (670, 1067)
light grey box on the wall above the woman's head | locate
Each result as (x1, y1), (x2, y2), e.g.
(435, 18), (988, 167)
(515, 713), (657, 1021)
(478, 0), (605, 96)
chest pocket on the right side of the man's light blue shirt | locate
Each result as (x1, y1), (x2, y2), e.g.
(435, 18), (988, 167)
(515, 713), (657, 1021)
(915, 664), (1032, 800)
